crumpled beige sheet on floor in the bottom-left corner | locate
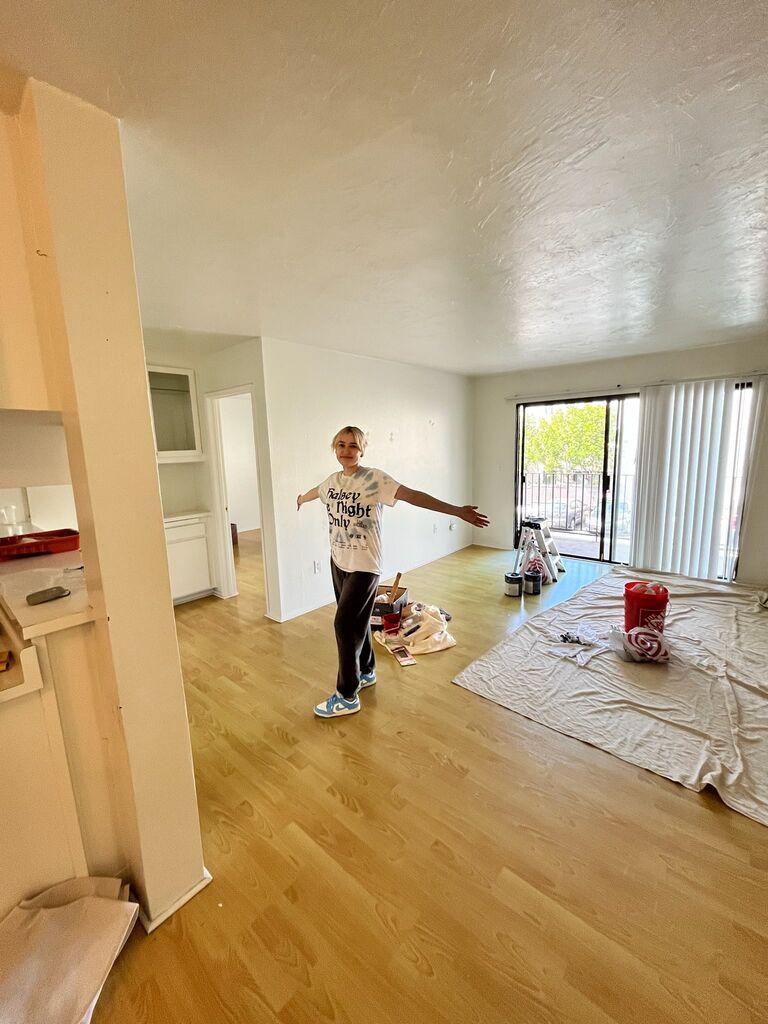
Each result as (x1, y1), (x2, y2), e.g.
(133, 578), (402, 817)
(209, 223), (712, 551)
(0, 879), (138, 1024)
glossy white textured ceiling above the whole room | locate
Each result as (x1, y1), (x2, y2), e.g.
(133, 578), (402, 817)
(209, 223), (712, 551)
(0, 0), (768, 373)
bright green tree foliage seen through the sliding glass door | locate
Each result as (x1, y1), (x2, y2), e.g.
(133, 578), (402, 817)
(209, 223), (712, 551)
(525, 404), (605, 473)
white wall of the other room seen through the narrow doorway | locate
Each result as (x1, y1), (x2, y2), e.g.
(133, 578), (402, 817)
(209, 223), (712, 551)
(219, 394), (261, 532)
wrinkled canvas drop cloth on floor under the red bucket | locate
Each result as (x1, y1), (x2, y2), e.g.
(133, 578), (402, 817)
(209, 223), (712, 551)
(454, 569), (768, 825)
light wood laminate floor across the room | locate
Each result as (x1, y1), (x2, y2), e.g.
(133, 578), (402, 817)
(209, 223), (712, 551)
(94, 534), (768, 1024)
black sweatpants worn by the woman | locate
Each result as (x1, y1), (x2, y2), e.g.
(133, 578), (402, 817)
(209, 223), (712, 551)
(331, 559), (379, 700)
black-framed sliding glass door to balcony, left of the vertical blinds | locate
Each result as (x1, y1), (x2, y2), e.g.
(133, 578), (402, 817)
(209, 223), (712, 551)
(515, 394), (640, 562)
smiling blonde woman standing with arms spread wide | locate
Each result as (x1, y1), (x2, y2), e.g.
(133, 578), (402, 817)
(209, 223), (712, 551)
(296, 427), (488, 718)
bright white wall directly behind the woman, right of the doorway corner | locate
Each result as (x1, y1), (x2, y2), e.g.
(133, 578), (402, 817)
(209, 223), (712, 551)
(262, 338), (476, 618)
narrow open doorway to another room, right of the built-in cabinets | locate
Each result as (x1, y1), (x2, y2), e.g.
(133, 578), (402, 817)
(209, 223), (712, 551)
(206, 386), (268, 613)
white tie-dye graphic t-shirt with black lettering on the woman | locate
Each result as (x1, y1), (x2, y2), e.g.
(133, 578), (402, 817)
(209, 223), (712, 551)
(317, 466), (399, 573)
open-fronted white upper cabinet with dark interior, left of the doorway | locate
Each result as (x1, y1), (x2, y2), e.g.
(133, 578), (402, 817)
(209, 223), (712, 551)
(146, 367), (203, 462)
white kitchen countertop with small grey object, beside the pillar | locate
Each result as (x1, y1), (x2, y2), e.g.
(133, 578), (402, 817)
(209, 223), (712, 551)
(0, 551), (94, 640)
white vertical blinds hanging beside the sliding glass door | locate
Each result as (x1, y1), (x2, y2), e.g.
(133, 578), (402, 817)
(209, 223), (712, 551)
(630, 379), (762, 580)
